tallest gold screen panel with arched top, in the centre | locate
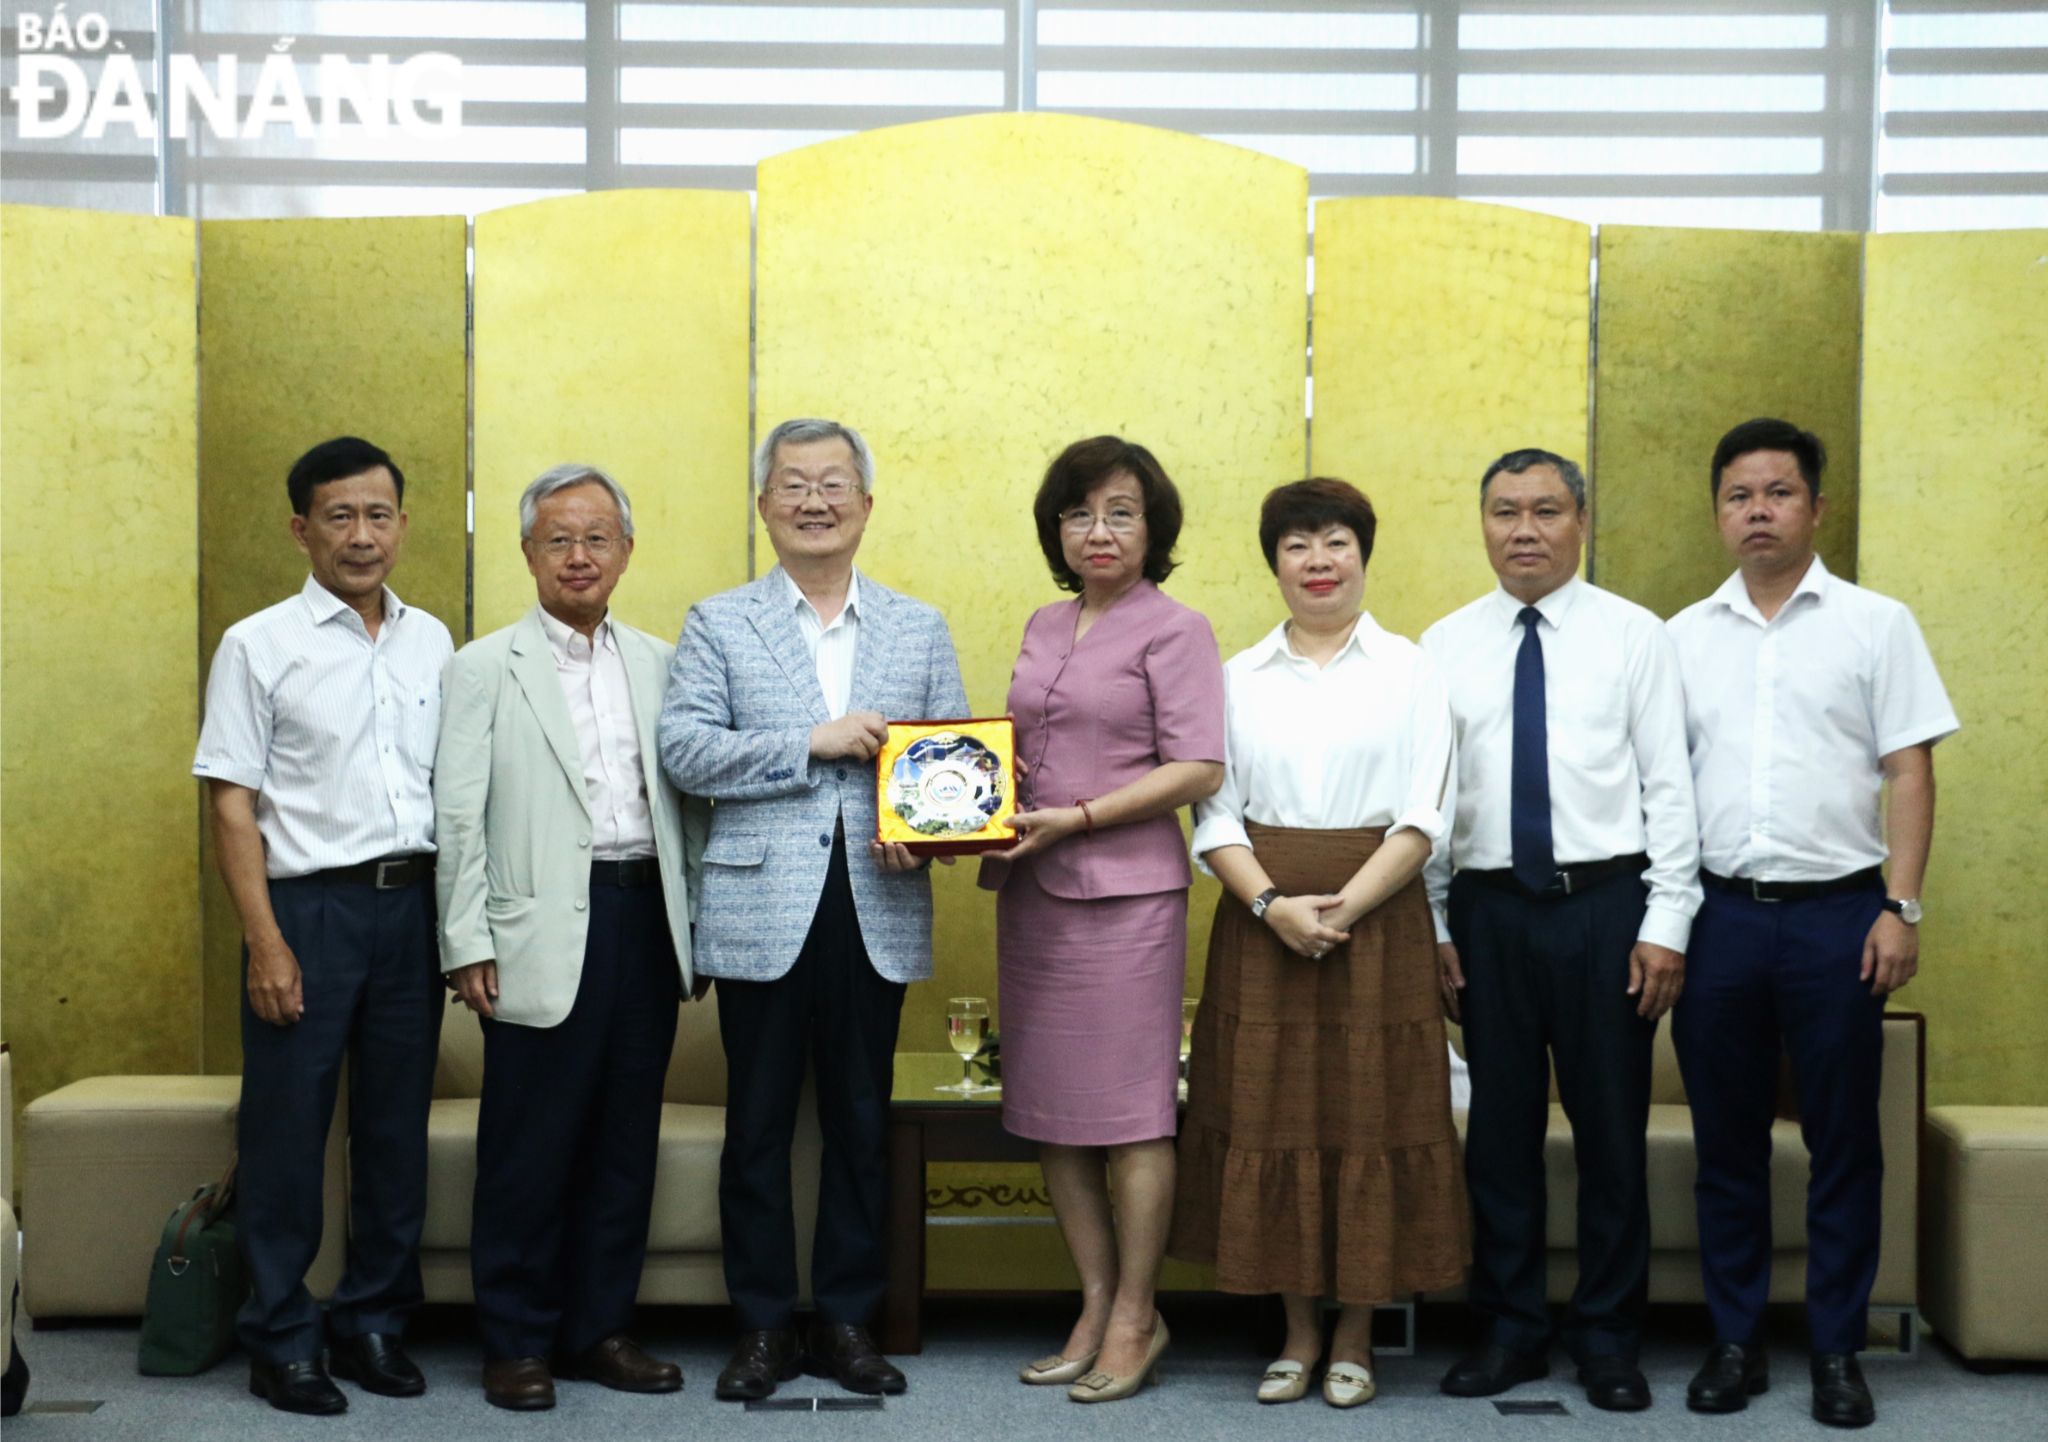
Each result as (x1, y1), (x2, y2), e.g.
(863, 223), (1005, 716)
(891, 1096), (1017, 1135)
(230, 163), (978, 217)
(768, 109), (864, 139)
(756, 115), (1307, 1081)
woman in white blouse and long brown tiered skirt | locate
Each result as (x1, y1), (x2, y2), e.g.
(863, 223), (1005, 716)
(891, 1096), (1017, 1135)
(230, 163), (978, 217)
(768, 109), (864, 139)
(1169, 479), (1470, 1407)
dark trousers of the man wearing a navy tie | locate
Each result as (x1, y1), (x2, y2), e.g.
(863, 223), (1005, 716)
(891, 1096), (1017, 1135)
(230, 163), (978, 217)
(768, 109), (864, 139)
(1448, 873), (1657, 1360)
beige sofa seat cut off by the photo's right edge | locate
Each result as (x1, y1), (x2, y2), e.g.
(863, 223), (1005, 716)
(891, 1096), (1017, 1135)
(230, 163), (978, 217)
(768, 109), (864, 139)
(1921, 1106), (2048, 1362)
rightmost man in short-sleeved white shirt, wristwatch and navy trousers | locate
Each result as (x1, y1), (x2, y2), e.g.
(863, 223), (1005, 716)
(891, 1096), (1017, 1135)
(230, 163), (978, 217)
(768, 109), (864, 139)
(1671, 420), (1958, 1428)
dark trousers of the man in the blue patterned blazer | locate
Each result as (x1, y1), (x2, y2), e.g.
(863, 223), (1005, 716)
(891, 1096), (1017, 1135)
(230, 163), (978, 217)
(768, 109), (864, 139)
(717, 834), (903, 1329)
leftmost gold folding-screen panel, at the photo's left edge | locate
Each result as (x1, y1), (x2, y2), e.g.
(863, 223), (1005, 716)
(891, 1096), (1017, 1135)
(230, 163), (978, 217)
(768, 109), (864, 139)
(0, 205), (201, 1102)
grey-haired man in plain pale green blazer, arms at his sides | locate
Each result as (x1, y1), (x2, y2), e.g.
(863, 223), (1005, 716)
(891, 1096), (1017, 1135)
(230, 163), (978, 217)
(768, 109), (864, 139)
(434, 465), (709, 1411)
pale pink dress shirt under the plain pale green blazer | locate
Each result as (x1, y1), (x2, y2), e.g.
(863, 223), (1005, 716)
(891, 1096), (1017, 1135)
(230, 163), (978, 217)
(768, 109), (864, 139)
(541, 606), (653, 860)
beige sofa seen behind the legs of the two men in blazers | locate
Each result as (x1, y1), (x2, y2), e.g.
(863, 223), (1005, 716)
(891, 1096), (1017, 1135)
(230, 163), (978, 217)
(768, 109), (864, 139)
(420, 995), (819, 1303)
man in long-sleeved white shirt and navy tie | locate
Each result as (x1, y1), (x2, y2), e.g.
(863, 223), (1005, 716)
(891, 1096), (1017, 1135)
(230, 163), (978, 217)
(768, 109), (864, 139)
(1421, 451), (1700, 1411)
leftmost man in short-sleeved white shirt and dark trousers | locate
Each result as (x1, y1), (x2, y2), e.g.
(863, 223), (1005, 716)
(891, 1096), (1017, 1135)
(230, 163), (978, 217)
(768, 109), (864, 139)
(193, 436), (455, 1415)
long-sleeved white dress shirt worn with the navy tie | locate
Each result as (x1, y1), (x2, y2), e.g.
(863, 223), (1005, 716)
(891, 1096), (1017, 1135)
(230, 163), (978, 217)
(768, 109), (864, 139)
(1421, 578), (1700, 950)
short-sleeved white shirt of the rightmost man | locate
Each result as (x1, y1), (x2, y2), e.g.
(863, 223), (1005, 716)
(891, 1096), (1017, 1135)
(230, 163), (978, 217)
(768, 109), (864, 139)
(1671, 557), (1960, 881)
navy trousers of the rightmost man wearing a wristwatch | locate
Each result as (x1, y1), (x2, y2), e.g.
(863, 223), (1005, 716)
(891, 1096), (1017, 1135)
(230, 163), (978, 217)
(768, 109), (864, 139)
(1671, 887), (1884, 1352)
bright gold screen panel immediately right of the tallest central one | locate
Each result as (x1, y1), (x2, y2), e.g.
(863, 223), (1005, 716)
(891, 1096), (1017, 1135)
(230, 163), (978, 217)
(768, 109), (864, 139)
(1311, 197), (1591, 637)
